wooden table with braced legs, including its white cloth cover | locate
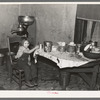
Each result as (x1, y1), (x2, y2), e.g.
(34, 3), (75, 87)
(34, 50), (100, 90)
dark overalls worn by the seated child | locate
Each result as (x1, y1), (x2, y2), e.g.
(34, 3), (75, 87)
(17, 53), (37, 81)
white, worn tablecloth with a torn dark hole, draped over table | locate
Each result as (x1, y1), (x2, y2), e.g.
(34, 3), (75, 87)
(34, 49), (94, 68)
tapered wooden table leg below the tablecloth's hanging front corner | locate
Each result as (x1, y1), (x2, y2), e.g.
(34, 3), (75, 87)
(59, 71), (70, 90)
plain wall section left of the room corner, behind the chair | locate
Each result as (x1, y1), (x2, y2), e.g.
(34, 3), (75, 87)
(0, 4), (19, 48)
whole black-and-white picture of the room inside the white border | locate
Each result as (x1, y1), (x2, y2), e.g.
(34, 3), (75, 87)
(0, 2), (100, 95)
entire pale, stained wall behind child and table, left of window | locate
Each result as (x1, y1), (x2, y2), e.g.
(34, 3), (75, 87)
(0, 4), (77, 48)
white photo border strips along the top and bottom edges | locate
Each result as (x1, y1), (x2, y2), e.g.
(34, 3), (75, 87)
(0, 0), (100, 100)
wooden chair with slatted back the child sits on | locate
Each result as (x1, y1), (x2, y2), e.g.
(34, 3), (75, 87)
(7, 36), (25, 90)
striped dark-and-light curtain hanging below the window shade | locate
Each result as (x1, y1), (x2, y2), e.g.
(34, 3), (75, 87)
(74, 19), (96, 44)
